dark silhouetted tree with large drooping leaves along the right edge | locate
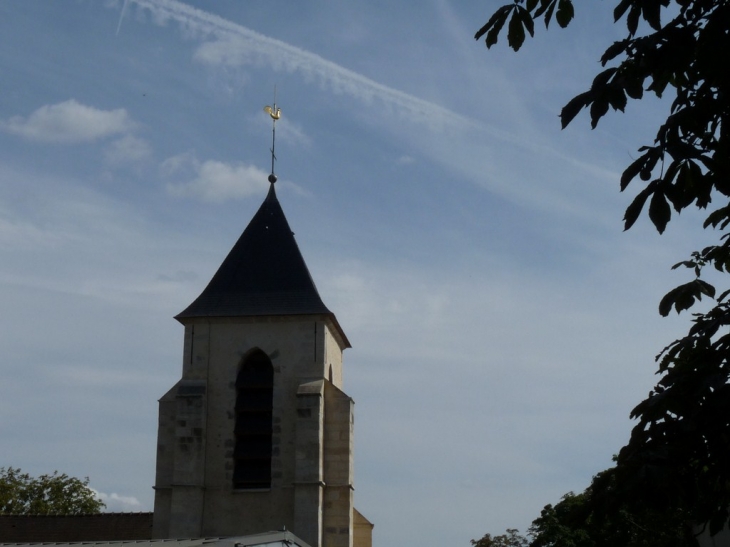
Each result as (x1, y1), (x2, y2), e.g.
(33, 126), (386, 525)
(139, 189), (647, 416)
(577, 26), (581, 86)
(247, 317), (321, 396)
(475, 0), (730, 545)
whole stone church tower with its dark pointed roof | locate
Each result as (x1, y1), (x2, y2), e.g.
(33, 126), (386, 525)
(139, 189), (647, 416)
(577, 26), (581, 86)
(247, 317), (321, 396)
(153, 183), (372, 547)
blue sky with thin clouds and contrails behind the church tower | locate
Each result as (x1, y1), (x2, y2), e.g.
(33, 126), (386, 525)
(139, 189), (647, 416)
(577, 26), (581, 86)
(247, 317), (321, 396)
(0, 0), (701, 547)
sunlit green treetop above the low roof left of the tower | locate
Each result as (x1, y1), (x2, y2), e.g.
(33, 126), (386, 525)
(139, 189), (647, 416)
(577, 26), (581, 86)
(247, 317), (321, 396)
(0, 467), (105, 515)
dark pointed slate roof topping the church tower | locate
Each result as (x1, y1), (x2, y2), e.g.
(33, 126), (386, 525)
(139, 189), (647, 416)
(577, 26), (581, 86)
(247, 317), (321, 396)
(176, 184), (349, 345)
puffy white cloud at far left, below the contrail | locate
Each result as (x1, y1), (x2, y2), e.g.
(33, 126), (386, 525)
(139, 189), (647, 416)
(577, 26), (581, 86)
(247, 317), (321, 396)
(0, 99), (134, 144)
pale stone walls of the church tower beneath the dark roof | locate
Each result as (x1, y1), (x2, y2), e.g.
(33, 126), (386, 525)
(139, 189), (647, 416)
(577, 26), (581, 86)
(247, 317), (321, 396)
(154, 316), (352, 546)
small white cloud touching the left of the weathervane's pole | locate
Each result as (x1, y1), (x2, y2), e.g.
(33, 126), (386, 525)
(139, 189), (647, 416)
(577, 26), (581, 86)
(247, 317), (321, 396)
(161, 152), (268, 202)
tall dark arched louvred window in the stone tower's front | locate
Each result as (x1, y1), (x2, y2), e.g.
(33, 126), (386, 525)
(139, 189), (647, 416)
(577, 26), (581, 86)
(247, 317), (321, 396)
(233, 350), (274, 489)
